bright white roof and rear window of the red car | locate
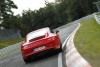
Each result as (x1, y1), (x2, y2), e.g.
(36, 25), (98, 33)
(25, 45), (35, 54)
(26, 27), (50, 40)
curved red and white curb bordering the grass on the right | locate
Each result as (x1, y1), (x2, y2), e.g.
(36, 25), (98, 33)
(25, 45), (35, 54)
(65, 24), (92, 67)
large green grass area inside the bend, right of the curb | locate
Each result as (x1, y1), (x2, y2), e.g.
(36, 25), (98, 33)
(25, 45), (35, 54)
(74, 18), (100, 67)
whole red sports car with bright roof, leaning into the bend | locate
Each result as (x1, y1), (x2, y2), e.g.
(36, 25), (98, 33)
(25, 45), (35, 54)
(21, 27), (61, 63)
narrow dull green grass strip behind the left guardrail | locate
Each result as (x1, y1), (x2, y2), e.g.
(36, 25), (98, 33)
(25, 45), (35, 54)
(0, 38), (24, 49)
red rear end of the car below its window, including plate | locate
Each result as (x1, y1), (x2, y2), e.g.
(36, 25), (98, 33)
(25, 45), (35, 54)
(21, 34), (61, 59)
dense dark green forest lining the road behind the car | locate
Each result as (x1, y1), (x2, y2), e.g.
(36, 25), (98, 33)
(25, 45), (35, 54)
(0, 0), (98, 37)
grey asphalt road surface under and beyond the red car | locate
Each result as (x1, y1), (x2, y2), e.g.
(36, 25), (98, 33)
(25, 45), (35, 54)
(0, 24), (78, 67)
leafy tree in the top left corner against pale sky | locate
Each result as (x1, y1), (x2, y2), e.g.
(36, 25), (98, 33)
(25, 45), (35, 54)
(0, 0), (17, 25)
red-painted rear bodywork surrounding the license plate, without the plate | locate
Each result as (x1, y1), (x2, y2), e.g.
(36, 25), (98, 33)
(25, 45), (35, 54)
(21, 36), (61, 59)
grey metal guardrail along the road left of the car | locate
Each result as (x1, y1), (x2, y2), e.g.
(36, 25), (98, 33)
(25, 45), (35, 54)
(0, 42), (22, 57)
